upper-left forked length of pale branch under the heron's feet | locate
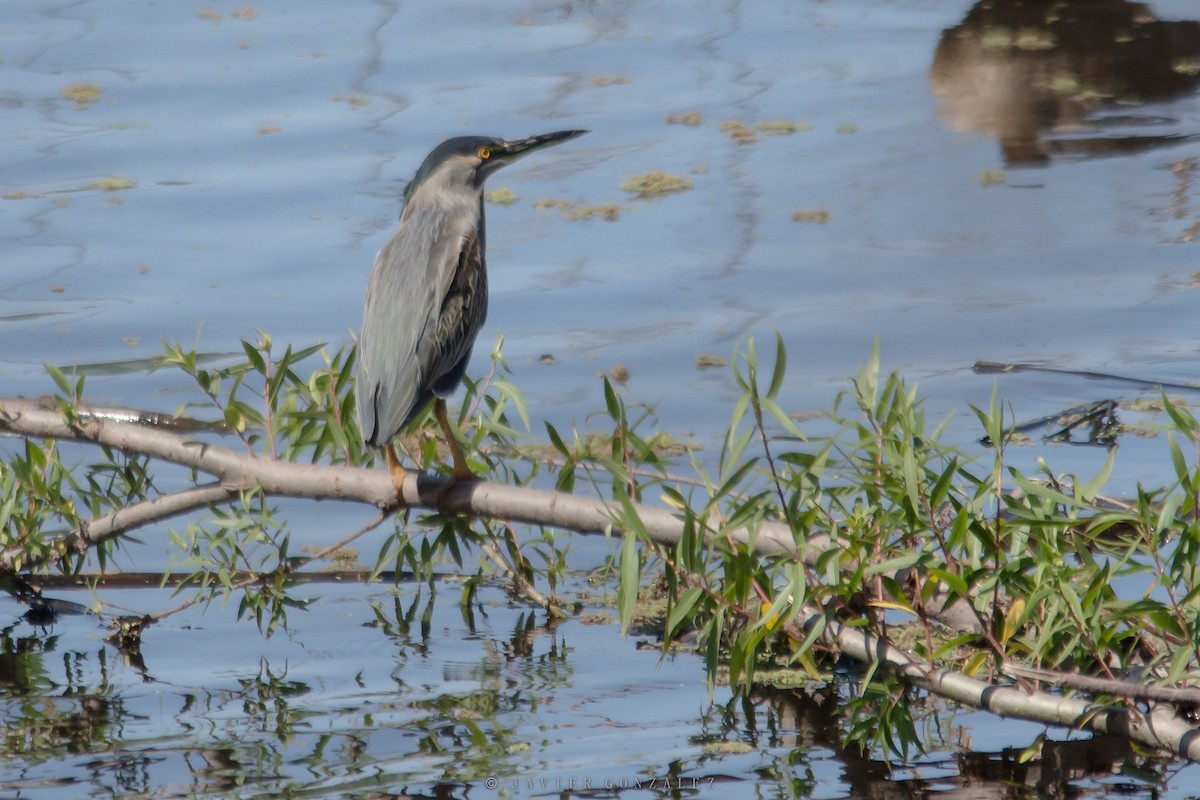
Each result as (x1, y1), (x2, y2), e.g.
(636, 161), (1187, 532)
(0, 397), (979, 632)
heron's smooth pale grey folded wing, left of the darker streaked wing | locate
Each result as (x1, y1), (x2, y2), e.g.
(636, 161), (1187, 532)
(358, 203), (474, 446)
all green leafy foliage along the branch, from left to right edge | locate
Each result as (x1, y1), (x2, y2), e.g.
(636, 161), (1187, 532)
(0, 333), (1200, 758)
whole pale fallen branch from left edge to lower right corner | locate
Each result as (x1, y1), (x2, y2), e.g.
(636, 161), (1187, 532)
(9, 398), (1200, 759)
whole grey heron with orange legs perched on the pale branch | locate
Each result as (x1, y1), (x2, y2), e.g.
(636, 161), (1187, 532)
(356, 131), (587, 494)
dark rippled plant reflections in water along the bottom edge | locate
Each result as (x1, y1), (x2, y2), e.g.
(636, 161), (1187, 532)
(0, 599), (1185, 800)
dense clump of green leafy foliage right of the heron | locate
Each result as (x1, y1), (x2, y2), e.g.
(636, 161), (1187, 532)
(588, 341), (1200, 757)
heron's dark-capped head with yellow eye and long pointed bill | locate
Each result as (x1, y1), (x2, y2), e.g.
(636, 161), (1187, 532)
(404, 131), (587, 199)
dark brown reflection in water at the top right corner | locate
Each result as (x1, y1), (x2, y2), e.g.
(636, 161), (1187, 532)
(930, 0), (1200, 164)
